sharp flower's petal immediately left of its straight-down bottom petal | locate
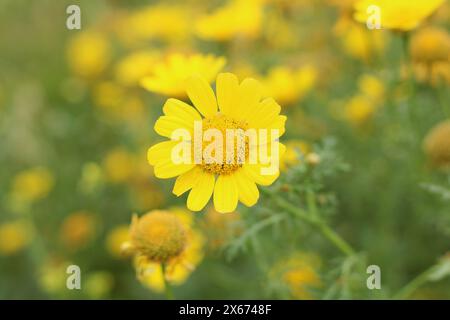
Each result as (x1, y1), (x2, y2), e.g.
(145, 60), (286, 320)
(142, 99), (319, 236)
(187, 172), (215, 211)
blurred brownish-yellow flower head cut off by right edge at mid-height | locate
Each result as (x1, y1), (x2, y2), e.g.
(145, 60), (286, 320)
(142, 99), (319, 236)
(423, 120), (450, 168)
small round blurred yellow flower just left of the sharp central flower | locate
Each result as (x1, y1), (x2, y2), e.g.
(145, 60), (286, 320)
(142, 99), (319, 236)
(103, 147), (136, 183)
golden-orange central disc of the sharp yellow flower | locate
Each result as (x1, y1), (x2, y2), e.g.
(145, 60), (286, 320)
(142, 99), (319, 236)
(200, 112), (249, 175)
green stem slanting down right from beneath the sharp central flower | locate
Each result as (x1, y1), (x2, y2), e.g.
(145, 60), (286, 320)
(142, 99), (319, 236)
(269, 193), (355, 256)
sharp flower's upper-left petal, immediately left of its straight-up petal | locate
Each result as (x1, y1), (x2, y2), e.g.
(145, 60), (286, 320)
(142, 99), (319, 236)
(186, 76), (217, 117)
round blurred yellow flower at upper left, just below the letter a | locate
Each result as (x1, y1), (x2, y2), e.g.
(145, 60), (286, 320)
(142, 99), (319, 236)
(67, 31), (109, 78)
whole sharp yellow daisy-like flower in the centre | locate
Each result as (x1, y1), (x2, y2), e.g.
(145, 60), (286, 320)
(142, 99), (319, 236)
(148, 73), (286, 213)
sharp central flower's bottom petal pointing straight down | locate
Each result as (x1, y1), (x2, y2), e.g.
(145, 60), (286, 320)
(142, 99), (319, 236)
(213, 175), (238, 213)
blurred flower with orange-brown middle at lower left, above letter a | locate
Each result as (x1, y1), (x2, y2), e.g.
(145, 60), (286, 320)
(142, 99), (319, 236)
(60, 211), (96, 250)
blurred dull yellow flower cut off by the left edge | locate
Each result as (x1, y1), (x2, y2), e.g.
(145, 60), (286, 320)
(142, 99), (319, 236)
(0, 220), (32, 255)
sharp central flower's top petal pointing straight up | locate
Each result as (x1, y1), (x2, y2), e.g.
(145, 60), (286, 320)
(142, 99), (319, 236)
(216, 73), (239, 116)
